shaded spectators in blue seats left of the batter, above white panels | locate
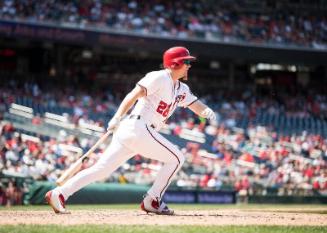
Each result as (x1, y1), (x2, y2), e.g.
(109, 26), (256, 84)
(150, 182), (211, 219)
(0, 80), (120, 126)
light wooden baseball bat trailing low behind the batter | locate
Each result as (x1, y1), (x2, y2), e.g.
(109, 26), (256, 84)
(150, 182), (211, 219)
(56, 131), (112, 186)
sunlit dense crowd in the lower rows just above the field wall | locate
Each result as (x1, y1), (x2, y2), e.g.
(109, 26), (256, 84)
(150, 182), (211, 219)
(1, 115), (327, 205)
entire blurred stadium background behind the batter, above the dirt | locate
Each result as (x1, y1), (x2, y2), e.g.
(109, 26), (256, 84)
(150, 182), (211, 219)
(0, 0), (327, 206)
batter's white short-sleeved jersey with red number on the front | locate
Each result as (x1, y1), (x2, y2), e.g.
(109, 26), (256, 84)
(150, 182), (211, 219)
(131, 70), (197, 130)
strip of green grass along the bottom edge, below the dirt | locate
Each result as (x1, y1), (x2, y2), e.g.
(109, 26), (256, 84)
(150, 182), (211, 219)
(0, 225), (327, 233)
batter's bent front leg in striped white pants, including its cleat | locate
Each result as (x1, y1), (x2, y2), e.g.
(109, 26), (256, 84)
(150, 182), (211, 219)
(138, 126), (185, 214)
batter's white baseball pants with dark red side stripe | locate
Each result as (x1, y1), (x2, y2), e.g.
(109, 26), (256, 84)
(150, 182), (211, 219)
(56, 119), (185, 200)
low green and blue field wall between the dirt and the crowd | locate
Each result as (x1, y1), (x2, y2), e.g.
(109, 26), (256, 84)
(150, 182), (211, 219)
(24, 182), (327, 204)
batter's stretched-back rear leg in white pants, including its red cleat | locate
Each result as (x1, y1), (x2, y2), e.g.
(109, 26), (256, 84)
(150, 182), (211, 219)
(46, 137), (134, 213)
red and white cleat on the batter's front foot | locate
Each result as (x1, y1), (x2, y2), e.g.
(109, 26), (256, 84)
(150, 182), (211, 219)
(141, 195), (174, 215)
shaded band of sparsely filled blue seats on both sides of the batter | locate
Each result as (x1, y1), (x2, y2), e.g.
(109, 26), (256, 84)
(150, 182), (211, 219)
(0, 80), (327, 137)
